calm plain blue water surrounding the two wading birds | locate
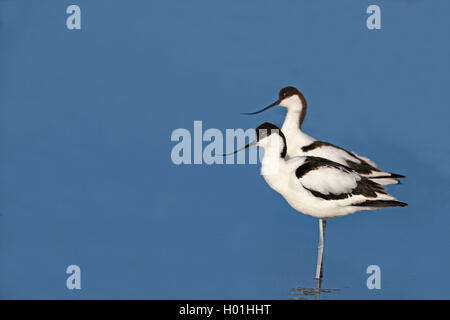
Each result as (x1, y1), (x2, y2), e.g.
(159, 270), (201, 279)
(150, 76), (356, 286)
(0, 0), (450, 299)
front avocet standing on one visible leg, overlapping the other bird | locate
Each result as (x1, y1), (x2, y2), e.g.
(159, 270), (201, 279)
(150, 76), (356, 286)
(227, 122), (407, 279)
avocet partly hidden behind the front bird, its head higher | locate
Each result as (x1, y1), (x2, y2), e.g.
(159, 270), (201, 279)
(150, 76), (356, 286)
(244, 87), (404, 185)
